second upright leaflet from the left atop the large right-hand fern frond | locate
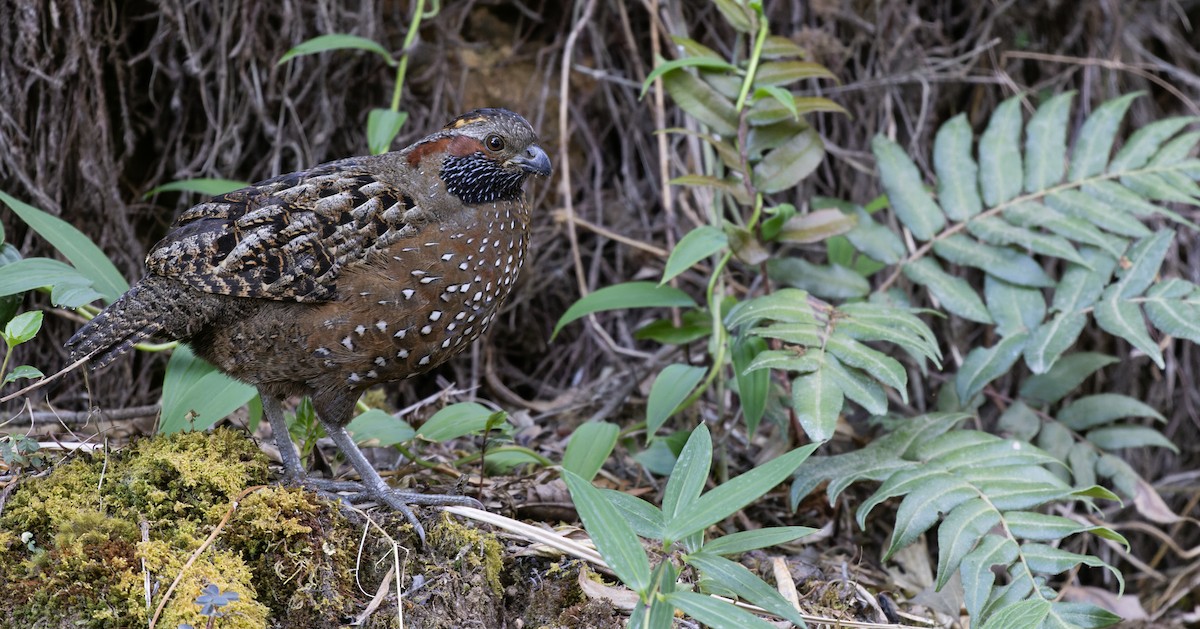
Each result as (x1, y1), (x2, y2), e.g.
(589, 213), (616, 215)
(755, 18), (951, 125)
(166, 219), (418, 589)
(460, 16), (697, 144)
(934, 114), (983, 221)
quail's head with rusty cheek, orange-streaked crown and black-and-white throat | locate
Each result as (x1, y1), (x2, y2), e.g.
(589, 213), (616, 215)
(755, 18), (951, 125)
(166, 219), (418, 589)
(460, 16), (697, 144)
(406, 109), (551, 205)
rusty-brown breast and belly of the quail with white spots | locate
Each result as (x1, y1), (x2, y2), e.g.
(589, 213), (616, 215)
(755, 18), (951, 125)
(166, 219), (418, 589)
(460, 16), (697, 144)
(300, 221), (524, 388)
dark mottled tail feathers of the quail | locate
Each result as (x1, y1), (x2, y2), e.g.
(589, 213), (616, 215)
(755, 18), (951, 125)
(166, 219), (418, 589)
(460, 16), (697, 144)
(66, 275), (178, 370)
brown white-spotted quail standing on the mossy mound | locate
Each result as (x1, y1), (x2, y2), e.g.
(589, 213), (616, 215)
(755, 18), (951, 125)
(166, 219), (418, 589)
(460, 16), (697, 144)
(67, 109), (551, 540)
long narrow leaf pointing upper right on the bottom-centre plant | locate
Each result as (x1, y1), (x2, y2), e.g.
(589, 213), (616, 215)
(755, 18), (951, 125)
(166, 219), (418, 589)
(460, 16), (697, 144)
(662, 443), (820, 541)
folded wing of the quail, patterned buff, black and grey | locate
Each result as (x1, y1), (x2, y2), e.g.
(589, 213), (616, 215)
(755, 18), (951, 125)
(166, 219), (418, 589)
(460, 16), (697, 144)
(146, 158), (413, 301)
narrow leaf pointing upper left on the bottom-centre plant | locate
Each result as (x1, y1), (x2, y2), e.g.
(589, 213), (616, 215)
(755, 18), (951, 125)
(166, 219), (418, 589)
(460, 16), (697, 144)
(563, 469), (650, 600)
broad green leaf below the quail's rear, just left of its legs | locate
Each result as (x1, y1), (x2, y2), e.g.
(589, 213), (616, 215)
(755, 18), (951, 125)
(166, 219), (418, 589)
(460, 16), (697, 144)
(158, 345), (258, 435)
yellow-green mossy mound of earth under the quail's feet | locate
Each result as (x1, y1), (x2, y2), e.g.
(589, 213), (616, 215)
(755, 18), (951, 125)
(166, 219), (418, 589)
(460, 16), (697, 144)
(0, 429), (622, 629)
